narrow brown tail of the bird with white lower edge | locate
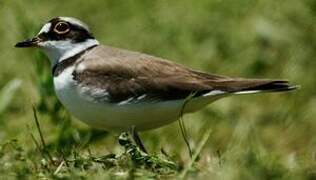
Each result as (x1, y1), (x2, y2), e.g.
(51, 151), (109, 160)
(211, 79), (300, 94)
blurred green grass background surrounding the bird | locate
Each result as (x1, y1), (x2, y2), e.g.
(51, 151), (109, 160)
(0, 0), (316, 179)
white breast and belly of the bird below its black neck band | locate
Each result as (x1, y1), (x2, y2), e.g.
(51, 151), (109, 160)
(54, 68), (219, 131)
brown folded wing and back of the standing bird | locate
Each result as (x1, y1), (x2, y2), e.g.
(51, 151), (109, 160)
(74, 46), (296, 102)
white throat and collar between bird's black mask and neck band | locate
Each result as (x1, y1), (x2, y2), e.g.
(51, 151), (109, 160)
(39, 39), (99, 67)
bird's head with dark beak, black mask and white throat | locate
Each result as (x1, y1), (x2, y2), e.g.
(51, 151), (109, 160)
(15, 17), (99, 64)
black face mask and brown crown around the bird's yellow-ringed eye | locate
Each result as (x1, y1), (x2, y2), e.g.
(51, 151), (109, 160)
(39, 18), (94, 43)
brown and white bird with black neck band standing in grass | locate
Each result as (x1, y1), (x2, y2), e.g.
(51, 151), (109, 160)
(15, 16), (298, 152)
